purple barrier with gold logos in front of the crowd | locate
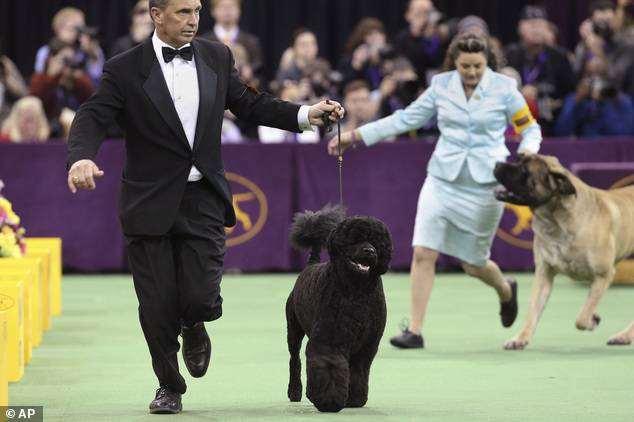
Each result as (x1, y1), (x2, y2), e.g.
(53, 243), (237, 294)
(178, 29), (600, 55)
(0, 138), (634, 272)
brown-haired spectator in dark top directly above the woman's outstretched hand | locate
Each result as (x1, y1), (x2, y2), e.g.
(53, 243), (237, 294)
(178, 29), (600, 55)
(338, 18), (396, 92)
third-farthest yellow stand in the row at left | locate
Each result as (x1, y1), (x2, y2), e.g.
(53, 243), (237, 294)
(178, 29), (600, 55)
(0, 257), (42, 347)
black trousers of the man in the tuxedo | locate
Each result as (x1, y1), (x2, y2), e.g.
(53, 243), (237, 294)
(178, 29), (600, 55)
(124, 181), (226, 394)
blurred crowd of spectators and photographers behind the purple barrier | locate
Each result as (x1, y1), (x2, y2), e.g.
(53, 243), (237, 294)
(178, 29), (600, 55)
(0, 0), (634, 143)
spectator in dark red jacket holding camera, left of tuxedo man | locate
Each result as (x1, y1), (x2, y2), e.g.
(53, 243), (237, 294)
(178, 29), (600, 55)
(29, 38), (94, 138)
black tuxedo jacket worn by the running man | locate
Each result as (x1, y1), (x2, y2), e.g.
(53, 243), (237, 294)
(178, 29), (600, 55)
(67, 39), (300, 235)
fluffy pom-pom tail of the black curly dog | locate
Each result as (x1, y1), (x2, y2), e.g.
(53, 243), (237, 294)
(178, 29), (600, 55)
(288, 204), (346, 251)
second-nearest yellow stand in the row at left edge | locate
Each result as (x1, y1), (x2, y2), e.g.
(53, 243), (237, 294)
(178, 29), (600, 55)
(0, 281), (24, 382)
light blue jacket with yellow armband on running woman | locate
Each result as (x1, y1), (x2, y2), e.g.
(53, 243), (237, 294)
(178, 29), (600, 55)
(359, 67), (542, 183)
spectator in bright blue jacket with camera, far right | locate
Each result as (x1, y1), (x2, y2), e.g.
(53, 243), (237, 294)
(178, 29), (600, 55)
(555, 57), (634, 137)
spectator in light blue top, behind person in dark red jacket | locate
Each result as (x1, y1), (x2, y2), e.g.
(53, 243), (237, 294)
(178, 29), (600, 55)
(34, 7), (105, 85)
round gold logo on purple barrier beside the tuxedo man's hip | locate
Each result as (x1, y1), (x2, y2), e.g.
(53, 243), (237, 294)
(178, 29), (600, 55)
(225, 173), (269, 247)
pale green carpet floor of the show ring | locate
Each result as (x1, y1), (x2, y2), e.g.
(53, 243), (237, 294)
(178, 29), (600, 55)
(9, 273), (634, 422)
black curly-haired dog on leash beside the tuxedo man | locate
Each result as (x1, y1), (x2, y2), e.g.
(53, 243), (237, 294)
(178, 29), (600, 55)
(286, 206), (392, 412)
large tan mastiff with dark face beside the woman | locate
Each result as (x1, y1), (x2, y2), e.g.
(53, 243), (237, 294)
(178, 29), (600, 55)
(495, 154), (634, 350)
